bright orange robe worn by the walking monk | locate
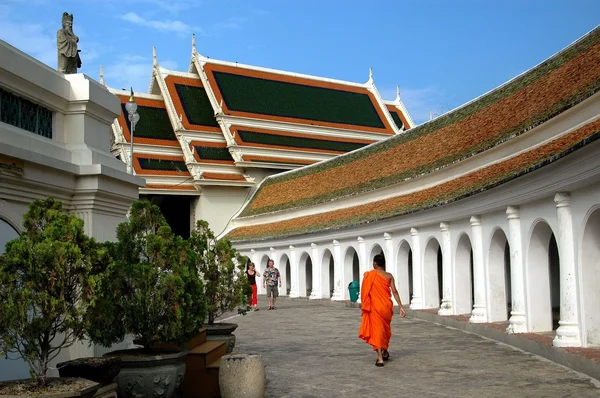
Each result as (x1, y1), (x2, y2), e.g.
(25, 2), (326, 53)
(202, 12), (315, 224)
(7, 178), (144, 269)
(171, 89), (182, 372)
(358, 270), (394, 350)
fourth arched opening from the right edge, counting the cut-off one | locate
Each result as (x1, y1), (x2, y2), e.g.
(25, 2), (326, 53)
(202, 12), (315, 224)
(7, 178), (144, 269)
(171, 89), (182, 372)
(453, 234), (474, 314)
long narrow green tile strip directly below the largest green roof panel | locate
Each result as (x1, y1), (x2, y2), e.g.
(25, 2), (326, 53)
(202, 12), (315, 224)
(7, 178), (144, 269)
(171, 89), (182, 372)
(238, 130), (367, 152)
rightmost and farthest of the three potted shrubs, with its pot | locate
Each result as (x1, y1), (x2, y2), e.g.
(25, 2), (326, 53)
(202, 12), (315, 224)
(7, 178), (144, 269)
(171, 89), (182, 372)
(189, 220), (252, 353)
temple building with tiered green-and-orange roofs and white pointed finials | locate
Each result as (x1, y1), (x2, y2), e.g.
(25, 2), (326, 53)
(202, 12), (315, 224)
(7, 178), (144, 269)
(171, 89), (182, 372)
(100, 35), (414, 237)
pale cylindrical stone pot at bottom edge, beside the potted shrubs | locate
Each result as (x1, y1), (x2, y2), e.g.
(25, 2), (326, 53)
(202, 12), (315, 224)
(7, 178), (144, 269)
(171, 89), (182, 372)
(219, 354), (267, 398)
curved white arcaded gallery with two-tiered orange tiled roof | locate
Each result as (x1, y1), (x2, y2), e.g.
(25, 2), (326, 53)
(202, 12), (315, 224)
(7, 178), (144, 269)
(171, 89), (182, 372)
(221, 27), (600, 347)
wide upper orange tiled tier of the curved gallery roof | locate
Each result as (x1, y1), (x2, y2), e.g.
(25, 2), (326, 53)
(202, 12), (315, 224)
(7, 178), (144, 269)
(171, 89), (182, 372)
(241, 28), (600, 217)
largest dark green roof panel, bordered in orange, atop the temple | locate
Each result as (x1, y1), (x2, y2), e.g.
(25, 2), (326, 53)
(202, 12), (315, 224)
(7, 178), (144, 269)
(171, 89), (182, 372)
(213, 71), (385, 129)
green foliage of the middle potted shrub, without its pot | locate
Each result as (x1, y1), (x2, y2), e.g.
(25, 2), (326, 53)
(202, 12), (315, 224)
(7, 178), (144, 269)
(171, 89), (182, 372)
(88, 201), (206, 348)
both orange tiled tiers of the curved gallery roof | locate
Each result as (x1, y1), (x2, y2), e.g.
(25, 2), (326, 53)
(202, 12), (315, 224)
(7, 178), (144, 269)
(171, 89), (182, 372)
(228, 28), (600, 240)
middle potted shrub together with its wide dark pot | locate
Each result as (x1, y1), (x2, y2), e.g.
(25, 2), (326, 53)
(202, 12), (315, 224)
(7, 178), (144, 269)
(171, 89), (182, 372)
(95, 201), (206, 397)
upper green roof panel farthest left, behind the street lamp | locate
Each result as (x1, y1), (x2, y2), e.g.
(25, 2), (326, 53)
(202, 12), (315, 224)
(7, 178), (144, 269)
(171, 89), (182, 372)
(121, 104), (177, 141)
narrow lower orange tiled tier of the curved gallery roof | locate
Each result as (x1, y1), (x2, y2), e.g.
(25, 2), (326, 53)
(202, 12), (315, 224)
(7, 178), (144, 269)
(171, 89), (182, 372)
(227, 119), (600, 241)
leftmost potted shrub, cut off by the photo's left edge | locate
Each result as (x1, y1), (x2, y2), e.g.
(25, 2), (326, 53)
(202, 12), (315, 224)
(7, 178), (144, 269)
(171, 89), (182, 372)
(0, 198), (111, 397)
